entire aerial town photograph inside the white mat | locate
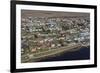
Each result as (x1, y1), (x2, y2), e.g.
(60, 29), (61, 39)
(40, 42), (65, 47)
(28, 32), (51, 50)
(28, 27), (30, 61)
(21, 10), (90, 63)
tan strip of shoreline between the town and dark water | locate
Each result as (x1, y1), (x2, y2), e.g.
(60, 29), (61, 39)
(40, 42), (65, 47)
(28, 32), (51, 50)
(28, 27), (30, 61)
(21, 44), (88, 63)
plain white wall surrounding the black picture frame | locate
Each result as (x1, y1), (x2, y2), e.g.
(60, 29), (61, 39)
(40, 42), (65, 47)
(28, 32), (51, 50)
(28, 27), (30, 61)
(0, 0), (100, 73)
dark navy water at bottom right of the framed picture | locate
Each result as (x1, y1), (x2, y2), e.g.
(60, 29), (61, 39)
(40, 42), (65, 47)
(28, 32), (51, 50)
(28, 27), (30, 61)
(39, 47), (90, 62)
